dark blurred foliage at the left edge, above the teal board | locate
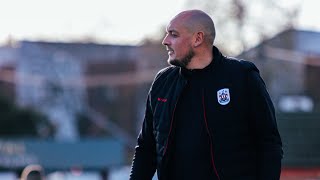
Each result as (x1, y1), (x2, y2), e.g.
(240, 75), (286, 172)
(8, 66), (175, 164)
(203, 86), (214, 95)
(0, 93), (54, 138)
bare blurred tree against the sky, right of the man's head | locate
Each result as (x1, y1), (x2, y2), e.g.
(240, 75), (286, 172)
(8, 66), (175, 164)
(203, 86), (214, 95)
(186, 0), (302, 55)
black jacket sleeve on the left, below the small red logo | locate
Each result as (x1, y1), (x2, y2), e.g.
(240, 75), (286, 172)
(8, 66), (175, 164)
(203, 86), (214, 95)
(130, 94), (156, 180)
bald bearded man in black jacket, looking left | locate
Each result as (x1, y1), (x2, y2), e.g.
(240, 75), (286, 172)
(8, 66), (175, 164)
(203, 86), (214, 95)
(130, 10), (283, 180)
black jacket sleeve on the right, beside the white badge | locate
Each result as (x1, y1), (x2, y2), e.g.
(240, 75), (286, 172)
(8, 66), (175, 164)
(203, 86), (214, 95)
(248, 66), (283, 180)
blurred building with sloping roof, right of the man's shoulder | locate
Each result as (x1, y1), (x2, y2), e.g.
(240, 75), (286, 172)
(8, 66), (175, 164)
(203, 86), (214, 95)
(239, 29), (320, 112)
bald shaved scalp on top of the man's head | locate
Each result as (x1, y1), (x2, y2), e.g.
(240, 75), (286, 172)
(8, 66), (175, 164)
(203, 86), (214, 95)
(172, 10), (216, 45)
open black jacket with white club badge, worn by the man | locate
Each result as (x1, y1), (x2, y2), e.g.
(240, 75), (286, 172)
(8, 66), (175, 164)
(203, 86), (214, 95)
(130, 47), (283, 180)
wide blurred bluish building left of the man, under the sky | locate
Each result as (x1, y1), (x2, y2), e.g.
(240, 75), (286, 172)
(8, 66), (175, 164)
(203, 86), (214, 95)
(0, 41), (167, 143)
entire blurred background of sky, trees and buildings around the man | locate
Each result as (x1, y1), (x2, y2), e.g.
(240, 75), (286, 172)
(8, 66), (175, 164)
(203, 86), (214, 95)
(0, 0), (320, 180)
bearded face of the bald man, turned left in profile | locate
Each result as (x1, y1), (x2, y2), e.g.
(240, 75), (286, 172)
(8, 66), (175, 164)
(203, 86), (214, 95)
(162, 18), (194, 67)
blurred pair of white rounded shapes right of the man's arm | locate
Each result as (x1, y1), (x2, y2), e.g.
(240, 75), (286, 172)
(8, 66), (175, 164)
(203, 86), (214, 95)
(278, 95), (314, 112)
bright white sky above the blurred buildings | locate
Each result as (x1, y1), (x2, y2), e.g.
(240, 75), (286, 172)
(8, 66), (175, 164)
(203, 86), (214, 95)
(0, 0), (320, 45)
